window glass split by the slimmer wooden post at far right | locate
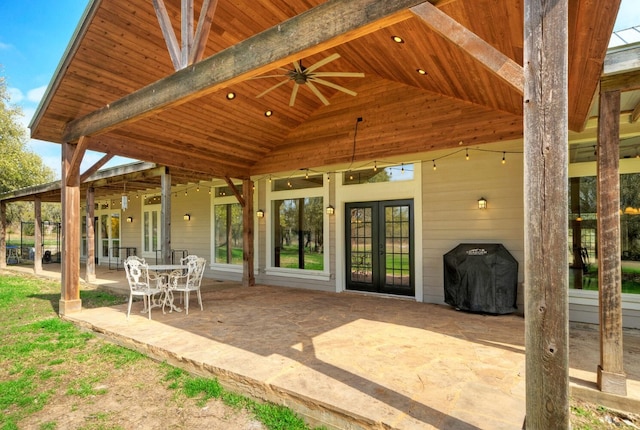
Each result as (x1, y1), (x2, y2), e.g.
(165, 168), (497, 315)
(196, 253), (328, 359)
(568, 173), (640, 294)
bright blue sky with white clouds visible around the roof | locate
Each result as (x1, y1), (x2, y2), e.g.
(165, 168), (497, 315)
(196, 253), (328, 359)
(0, 0), (640, 177)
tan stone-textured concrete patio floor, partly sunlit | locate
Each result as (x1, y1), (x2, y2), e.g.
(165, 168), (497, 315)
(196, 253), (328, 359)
(9, 265), (640, 429)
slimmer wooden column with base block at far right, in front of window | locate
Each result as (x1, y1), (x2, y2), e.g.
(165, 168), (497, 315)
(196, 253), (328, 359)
(597, 91), (627, 396)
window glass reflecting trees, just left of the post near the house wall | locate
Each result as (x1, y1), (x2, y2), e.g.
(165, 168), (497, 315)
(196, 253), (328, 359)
(214, 203), (243, 264)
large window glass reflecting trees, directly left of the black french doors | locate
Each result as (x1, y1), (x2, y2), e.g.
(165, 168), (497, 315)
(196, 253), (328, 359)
(273, 197), (324, 270)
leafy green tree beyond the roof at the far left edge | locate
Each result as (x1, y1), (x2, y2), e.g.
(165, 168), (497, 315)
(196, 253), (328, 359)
(0, 77), (59, 224)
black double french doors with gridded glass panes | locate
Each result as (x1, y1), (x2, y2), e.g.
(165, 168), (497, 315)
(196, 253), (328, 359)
(345, 200), (415, 296)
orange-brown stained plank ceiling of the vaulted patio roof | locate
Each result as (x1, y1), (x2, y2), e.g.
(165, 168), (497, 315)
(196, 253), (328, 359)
(32, 0), (619, 178)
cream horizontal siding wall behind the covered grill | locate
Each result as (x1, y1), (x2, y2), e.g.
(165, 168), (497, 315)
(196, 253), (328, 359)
(422, 141), (524, 312)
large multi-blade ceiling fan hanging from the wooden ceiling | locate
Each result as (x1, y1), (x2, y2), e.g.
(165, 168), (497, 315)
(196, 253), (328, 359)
(255, 54), (364, 106)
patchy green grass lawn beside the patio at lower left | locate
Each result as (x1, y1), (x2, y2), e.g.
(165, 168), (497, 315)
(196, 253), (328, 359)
(0, 274), (322, 430)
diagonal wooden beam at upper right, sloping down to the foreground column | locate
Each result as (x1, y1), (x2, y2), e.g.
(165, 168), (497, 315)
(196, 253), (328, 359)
(411, 2), (524, 94)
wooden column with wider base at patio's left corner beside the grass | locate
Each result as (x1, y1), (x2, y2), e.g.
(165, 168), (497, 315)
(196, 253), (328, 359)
(59, 143), (82, 315)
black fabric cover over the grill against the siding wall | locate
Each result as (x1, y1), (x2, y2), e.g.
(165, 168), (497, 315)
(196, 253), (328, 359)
(443, 243), (518, 314)
